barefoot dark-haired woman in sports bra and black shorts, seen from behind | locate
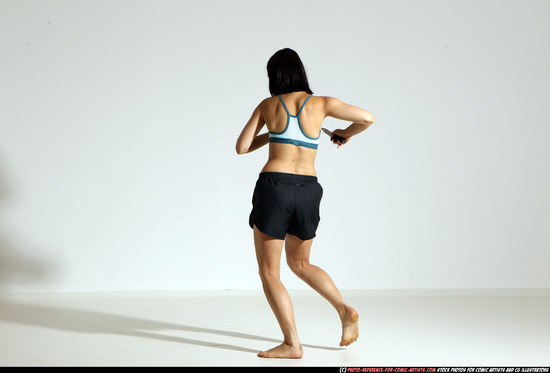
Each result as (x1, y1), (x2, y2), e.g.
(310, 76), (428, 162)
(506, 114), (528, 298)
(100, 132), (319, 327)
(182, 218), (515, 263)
(236, 48), (374, 358)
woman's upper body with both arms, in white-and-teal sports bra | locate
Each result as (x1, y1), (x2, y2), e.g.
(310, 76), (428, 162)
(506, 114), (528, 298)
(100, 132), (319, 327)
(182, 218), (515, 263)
(236, 91), (374, 176)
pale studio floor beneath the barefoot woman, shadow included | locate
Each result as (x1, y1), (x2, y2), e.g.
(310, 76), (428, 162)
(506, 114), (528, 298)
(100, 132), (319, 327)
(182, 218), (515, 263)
(0, 290), (550, 367)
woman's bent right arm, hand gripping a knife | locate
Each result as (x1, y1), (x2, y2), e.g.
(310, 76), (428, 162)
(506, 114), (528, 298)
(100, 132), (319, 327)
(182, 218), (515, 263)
(325, 97), (374, 146)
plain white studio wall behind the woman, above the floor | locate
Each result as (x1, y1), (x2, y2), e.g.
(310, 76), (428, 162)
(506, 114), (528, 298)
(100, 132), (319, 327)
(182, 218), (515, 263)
(0, 0), (550, 292)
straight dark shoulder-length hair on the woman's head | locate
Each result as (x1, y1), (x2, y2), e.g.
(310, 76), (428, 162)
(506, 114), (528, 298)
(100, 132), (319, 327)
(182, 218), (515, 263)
(267, 48), (313, 96)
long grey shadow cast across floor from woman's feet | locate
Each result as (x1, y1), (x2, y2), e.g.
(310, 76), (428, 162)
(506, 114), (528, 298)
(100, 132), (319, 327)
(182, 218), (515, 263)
(0, 299), (343, 354)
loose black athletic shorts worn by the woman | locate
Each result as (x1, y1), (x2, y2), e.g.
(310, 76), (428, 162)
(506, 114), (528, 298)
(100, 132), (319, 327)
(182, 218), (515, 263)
(249, 172), (323, 240)
